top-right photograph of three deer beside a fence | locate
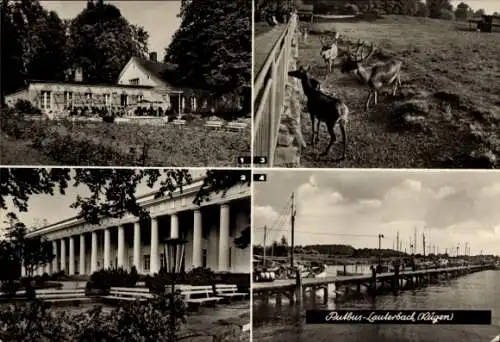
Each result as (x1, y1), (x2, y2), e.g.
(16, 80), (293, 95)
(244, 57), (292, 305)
(253, 0), (500, 169)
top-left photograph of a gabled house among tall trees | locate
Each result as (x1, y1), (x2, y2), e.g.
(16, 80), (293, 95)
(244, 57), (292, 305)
(0, 0), (252, 167)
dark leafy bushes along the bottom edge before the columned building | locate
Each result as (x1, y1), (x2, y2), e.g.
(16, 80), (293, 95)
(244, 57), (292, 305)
(0, 295), (186, 342)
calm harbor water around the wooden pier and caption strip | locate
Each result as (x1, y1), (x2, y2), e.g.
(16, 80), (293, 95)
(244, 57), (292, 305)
(253, 267), (500, 342)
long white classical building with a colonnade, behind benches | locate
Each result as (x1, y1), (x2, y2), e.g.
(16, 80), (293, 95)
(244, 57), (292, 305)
(27, 178), (251, 275)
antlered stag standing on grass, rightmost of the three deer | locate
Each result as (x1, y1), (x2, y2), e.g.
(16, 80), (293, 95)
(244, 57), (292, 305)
(341, 41), (403, 111)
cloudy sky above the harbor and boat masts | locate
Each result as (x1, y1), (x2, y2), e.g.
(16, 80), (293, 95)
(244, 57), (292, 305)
(253, 170), (500, 255)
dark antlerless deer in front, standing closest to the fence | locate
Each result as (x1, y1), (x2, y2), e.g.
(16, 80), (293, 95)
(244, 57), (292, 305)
(288, 65), (349, 160)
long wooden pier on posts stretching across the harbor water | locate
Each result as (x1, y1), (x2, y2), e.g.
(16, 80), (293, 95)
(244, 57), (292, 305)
(252, 265), (495, 306)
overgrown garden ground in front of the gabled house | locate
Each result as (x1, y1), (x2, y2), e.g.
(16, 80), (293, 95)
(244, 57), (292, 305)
(0, 118), (250, 167)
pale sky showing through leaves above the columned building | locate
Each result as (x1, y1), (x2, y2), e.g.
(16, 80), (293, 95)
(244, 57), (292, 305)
(0, 169), (206, 231)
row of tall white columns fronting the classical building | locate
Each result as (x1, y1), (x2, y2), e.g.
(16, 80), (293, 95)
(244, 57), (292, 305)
(48, 204), (229, 275)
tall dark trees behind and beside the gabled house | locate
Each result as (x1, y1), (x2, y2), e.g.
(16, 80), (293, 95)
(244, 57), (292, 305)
(1, 0), (251, 105)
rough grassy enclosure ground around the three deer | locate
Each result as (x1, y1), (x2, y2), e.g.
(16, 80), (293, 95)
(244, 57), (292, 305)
(299, 16), (500, 168)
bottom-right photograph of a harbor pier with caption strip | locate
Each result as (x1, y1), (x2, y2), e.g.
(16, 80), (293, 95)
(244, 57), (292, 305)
(252, 170), (500, 342)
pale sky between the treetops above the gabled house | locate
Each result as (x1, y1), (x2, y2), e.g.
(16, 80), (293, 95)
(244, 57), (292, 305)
(40, 0), (181, 61)
